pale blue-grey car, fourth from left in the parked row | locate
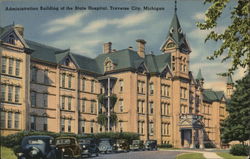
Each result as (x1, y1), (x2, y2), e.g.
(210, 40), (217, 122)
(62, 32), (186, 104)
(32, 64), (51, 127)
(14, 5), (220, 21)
(98, 138), (114, 153)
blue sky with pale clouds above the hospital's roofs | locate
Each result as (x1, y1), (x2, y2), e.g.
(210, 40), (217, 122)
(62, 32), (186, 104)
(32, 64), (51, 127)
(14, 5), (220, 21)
(0, 0), (244, 90)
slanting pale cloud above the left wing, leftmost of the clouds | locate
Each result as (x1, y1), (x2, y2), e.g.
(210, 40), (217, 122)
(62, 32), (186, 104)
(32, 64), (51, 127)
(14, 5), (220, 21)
(44, 12), (89, 34)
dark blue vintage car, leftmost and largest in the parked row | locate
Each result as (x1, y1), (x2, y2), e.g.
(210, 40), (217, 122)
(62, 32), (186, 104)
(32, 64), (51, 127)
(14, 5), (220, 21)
(16, 135), (61, 159)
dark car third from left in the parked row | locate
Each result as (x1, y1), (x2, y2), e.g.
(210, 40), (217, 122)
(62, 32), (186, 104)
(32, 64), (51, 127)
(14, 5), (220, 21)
(78, 138), (99, 157)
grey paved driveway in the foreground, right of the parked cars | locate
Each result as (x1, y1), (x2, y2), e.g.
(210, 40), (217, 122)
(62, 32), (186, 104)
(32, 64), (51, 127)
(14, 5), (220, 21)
(86, 151), (183, 159)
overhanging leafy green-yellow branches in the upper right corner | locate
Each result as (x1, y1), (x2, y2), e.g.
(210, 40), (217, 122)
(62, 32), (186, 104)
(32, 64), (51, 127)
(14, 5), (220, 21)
(197, 0), (250, 75)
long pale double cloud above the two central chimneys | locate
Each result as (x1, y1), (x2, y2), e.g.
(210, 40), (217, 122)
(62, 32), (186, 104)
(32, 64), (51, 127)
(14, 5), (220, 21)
(81, 12), (152, 33)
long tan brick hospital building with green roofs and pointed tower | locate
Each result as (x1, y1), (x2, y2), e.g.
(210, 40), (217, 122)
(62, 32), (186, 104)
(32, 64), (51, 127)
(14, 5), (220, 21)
(0, 13), (232, 147)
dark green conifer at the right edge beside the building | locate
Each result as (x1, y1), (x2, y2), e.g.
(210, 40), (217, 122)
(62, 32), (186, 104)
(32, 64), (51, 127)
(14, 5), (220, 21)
(222, 72), (250, 143)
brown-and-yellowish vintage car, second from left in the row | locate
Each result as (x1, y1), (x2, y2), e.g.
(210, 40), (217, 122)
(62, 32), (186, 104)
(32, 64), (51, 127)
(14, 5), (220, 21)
(55, 137), (81, 159)
